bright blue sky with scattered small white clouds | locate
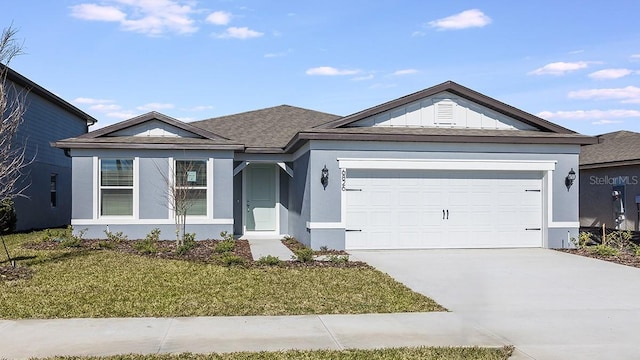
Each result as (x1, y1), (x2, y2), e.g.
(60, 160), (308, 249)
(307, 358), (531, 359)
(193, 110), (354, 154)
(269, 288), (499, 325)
(0, 0), (640, 135)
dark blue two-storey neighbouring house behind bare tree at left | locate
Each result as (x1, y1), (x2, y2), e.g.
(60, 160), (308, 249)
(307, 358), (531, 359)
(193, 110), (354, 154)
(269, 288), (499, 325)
(0, 64), (97, 231)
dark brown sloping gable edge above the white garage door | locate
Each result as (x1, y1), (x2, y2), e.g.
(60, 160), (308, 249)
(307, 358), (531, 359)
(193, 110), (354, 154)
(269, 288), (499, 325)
(317, 81), (575, 134)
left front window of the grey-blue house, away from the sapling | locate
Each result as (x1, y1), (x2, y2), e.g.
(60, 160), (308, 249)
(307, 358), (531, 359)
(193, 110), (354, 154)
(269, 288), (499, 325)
(100, 159), (133, 216)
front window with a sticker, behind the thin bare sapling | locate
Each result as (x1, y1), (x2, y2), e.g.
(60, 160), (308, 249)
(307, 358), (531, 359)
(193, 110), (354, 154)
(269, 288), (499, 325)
(175, 160), (207, 216)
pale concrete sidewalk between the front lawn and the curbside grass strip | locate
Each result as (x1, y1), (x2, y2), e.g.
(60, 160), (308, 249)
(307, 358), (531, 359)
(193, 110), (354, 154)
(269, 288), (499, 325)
(0, 312), (507, 359)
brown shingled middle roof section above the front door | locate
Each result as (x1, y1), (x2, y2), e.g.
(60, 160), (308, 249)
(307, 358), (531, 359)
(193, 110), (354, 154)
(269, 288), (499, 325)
(190, 105), (340, 153)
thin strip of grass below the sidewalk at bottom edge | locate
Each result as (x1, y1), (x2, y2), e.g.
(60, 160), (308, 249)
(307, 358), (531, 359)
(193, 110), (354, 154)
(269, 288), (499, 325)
(41, 346), (513, 360)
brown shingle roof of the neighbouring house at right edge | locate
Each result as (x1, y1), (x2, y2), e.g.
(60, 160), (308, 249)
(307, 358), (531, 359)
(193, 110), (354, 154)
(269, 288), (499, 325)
(580, 131), (640, 169)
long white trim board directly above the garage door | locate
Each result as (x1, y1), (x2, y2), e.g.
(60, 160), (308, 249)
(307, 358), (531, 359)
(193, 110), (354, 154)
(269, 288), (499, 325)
(338, 158), (557, 171)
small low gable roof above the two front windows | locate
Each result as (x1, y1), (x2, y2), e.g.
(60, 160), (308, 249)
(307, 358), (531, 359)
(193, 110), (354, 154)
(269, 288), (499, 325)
(53, 111), (244, 150)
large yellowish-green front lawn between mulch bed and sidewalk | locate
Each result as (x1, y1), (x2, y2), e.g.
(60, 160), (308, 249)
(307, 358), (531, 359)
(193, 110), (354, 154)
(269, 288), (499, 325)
(0, 232), (445, 319)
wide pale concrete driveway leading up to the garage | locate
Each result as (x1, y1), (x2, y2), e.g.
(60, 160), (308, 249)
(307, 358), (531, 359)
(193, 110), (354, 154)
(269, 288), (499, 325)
(350, 249), (640, 359)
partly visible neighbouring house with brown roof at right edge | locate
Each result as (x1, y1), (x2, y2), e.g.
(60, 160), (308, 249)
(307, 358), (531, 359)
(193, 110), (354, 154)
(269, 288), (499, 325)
(580, 131), (640, 231)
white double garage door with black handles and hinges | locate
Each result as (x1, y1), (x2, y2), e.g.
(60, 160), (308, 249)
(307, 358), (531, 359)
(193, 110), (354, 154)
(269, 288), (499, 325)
(345, 169), (542, 249)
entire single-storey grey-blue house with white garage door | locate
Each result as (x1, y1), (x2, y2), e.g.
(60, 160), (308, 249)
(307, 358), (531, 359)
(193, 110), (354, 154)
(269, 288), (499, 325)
(55, 82), (595, 249)
